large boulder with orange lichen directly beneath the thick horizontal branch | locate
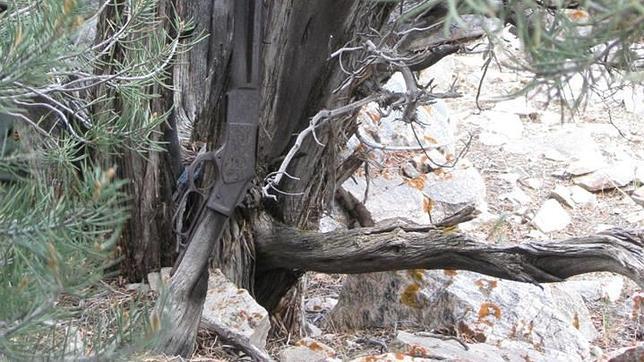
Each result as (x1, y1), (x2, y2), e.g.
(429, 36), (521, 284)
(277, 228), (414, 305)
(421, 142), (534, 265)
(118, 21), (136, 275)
(327, 269), (597, 361)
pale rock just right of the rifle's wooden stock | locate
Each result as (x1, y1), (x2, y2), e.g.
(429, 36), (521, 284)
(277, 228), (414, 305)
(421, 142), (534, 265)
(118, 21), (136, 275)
(201, 269), (271, 349)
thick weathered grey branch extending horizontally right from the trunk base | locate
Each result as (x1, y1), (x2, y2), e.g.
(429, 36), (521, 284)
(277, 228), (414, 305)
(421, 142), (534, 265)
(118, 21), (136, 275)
(256, 223), (644, 286)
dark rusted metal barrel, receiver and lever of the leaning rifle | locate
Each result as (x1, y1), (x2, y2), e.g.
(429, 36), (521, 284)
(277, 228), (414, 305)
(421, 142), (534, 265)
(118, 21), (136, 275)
(175, 0), (262, 269)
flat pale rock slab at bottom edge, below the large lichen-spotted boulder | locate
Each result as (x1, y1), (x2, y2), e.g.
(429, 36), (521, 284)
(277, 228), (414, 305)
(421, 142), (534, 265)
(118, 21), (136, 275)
(392, 331), (580, 362)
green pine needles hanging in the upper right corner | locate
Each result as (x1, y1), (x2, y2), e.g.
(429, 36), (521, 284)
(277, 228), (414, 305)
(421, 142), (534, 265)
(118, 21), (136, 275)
(399, 0), (644, 108)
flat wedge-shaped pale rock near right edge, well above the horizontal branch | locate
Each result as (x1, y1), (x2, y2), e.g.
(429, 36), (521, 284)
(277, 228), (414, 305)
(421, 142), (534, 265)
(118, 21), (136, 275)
(573, 162), (635, 192)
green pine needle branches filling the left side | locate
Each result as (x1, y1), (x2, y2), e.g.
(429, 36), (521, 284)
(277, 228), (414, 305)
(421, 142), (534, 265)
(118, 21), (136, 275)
(0, 0), (190, 360)
